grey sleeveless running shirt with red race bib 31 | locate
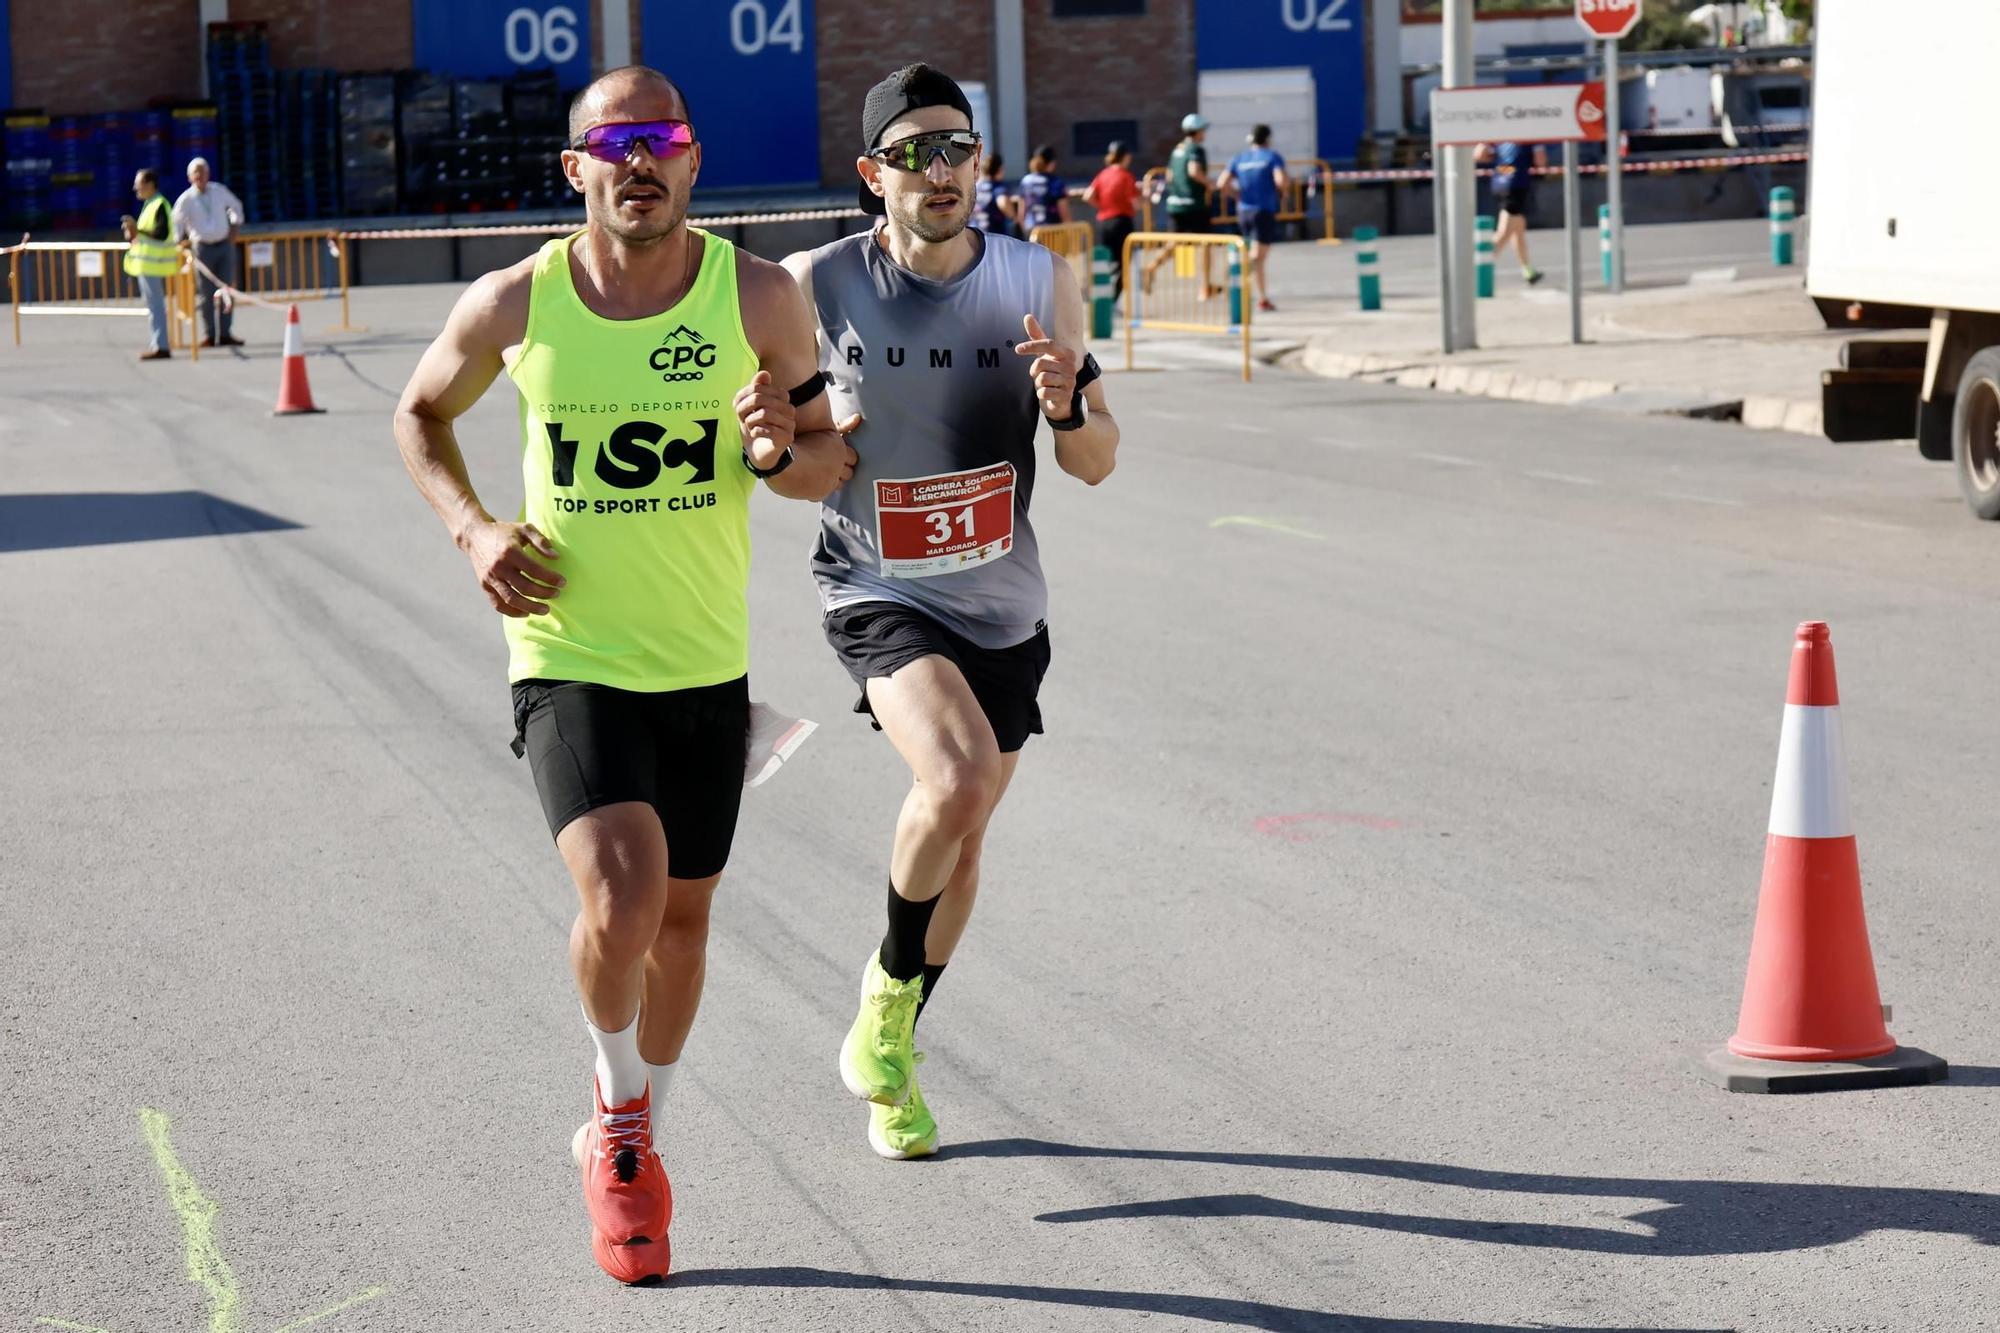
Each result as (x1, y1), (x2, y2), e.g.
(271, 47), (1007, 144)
(812, 232), (1056, 648)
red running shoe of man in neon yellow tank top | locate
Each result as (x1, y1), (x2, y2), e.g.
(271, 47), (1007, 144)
(580, 1083), (674, 1283)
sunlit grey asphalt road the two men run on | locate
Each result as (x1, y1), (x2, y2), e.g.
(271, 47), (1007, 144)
(0, 262), (2000, 1333)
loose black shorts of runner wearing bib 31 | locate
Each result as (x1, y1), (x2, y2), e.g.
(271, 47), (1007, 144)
(826, 602), (1048, 755)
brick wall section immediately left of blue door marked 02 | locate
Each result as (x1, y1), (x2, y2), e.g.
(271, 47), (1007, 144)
(1010, 0), (1192, 184)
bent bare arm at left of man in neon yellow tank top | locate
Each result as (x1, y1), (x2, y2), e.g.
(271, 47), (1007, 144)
(394, 258), (562, 616)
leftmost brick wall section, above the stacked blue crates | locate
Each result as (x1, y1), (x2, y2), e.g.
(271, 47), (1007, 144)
(8, 0), (202, 116)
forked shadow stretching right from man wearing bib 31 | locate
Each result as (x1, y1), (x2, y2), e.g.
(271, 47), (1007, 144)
(940, 1136), (2000, 1257)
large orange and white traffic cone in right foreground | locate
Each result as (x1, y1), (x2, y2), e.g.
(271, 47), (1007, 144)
(1702, 620), (1946, 1093)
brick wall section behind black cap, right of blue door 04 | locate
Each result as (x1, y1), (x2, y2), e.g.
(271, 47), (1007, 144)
(814, 0), (996, 195)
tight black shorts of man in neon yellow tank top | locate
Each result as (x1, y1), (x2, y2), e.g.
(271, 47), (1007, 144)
(514, 677), (750, 879)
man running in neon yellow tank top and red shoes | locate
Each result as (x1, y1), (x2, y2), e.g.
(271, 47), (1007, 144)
(396, 66), (860, 1281)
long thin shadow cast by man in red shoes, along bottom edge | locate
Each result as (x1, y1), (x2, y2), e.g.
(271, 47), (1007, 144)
(662, 1267), (1708, 1333)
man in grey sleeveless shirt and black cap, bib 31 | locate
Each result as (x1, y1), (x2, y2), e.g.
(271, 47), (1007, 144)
(786, 64), (1118, 1159)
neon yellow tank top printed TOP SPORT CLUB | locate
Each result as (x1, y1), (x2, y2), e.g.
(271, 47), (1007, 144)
(506, 226), (758, 691)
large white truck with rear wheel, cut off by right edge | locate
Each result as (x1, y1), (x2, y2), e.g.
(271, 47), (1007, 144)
(1806, 0), (2000, 518)
